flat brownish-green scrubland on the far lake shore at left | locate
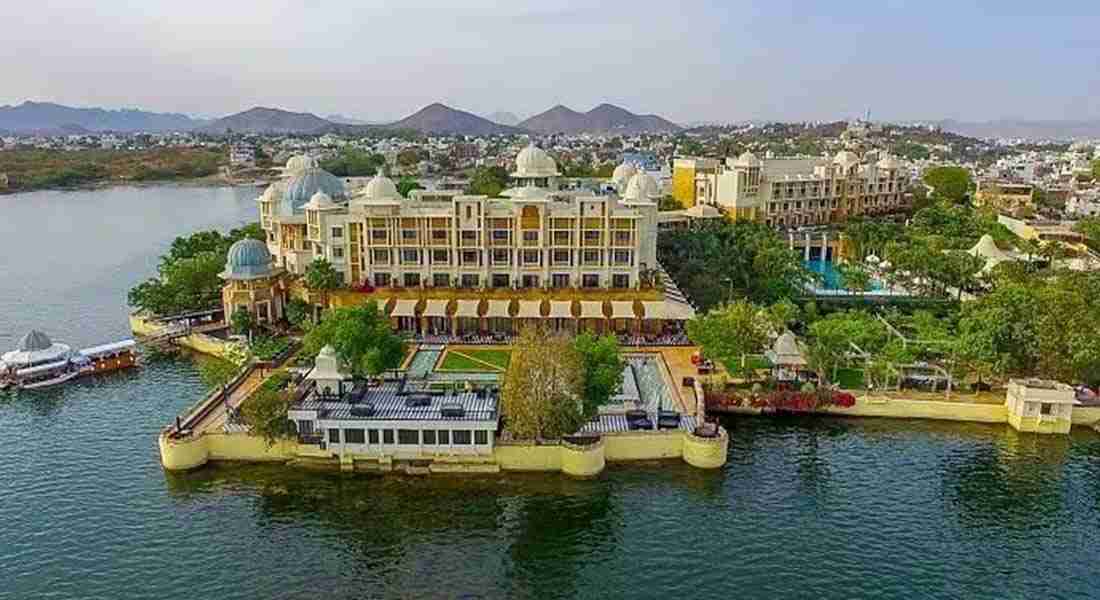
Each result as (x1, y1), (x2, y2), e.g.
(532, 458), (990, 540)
(0, 148), (226, 190)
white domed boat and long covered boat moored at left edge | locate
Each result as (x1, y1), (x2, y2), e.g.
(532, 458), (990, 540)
(0, 330), (138, 390)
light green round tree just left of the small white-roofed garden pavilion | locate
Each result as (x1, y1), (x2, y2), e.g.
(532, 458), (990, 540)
(688, 299), (769, 375)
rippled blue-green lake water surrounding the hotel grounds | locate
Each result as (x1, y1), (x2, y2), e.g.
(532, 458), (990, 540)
(0, 187), (1100, 600)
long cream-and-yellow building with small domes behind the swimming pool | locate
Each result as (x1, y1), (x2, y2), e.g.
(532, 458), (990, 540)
(673, 151), (910, 227)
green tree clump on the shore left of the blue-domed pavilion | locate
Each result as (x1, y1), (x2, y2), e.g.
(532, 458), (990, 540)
(128, 223), (265, 315)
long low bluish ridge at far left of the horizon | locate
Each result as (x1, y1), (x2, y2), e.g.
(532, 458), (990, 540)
(0, 101), (205, 133)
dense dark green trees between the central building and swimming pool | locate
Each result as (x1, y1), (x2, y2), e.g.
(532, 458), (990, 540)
(657, 219), (813, 310)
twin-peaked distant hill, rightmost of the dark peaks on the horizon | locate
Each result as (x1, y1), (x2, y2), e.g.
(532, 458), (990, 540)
(519, 103), (681, 134)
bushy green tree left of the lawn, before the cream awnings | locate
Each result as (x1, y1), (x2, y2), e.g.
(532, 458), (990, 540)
(303, 301), (405, 377)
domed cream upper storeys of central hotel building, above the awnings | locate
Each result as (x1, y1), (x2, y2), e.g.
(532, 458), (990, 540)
(259, 146), (659, 290)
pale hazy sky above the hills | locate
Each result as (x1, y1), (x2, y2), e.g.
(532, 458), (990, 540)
(0, 0), (1100, 122)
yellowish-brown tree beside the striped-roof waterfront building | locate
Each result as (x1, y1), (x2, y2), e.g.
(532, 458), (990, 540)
(501, 327), (584, 439)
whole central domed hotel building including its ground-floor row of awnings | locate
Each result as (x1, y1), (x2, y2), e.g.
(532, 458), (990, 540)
(227, 145), (693, 332)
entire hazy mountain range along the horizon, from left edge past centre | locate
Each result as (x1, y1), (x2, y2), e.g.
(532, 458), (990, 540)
(0, 102), (680, 135)
